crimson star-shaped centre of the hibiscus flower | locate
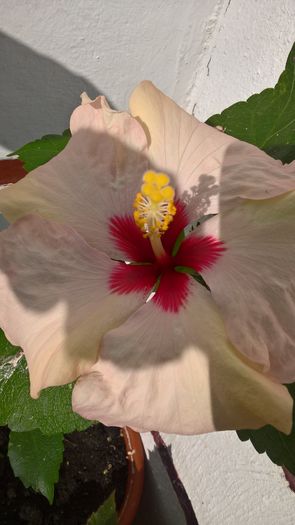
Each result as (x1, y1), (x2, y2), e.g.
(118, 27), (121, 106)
(109, 202), (224, 312)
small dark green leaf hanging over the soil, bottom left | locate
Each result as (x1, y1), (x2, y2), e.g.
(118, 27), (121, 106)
(8, 430), (63, 503)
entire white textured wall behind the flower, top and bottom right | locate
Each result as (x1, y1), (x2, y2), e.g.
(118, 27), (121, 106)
(0, 0), (295, 525)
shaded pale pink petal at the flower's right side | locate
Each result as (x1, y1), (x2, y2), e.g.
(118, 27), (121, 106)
(200, 192), (295, 383)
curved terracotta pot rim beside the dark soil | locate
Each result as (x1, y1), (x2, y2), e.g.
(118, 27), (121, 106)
(118, 427), (144, 525)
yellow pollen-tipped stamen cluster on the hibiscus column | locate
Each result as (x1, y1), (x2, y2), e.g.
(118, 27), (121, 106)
(133, 171), (176, 237)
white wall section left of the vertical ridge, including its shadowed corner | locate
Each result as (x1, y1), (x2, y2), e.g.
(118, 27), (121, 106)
(0, 0), (216, 156)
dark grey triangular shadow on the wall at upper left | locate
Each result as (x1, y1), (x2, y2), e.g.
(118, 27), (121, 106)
(0, 32), (106, 151)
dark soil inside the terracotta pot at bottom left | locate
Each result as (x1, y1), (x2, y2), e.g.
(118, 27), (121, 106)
(0, 425), (128, 525)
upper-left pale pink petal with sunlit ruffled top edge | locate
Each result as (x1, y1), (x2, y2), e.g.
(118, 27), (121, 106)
(0, 98), (147, 255)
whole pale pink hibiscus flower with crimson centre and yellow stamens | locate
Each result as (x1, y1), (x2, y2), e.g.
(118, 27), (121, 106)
(0, 82), (295, 434)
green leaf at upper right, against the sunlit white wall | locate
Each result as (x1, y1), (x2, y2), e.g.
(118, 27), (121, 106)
(207, 44), (295, 162)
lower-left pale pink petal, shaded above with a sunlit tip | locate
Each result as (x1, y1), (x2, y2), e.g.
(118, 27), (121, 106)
(0, 216), (143, 397)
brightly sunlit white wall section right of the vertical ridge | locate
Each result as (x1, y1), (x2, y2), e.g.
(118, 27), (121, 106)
(191, 0), (295, 119)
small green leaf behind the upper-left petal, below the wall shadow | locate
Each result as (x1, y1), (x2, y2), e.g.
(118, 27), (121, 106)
(9, 129), (71, 171)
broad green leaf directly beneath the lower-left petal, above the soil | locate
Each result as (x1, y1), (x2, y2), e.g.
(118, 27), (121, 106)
(0, 334), (93, 434)
